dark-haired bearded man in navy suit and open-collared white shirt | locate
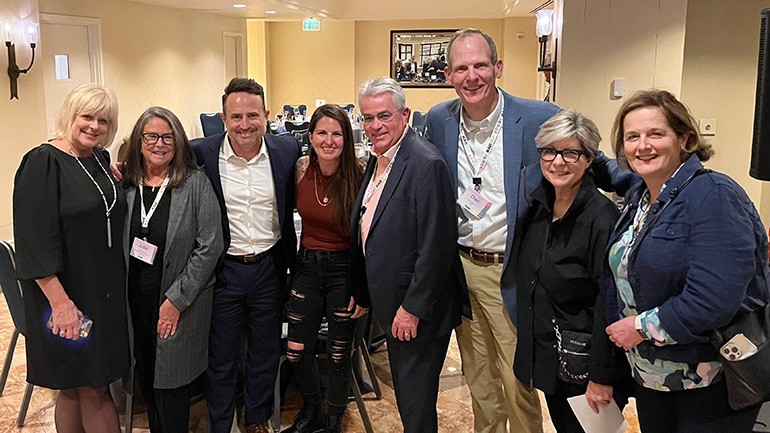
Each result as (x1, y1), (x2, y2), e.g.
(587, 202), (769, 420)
(192, 78), (299, 433)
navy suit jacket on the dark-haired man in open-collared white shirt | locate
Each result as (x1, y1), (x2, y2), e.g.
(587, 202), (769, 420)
(191, 132), (300, 280)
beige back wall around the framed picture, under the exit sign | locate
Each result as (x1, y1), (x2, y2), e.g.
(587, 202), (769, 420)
(255, 18), (538, 115)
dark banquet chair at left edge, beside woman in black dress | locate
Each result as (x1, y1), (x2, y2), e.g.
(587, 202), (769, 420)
(0, 241), (35, 427)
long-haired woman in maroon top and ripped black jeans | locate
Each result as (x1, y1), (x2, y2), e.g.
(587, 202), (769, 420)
(284, 104), (363, 433)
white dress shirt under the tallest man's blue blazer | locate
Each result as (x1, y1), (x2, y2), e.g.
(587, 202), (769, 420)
(457, 89), (508, 253)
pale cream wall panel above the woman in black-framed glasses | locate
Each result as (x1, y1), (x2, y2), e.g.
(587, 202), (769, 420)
(555, 0), (687, 152)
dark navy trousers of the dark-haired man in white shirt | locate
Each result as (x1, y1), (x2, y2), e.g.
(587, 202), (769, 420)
(206, 256), (283, 433)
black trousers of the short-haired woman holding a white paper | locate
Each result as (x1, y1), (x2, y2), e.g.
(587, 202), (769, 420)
(545, 376), (634, 433)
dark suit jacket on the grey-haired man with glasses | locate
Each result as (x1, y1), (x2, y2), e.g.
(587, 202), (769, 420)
(350, 128), (470, 341)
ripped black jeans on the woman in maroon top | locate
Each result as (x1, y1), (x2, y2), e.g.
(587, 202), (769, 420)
(286, 247), (356, 406)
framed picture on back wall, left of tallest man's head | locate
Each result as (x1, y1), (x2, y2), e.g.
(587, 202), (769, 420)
(390, 30), (457, 87)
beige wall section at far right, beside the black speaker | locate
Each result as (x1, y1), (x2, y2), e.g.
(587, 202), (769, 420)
(682, 0), (770, 216)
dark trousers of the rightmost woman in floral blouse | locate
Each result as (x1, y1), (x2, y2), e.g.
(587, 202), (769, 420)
(635, 377), (759, 433)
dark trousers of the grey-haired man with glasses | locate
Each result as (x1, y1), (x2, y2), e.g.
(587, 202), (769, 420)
(385, 329), (452, 433)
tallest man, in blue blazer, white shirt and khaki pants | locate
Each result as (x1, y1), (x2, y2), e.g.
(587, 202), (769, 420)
(426, 29), (627, 433)
